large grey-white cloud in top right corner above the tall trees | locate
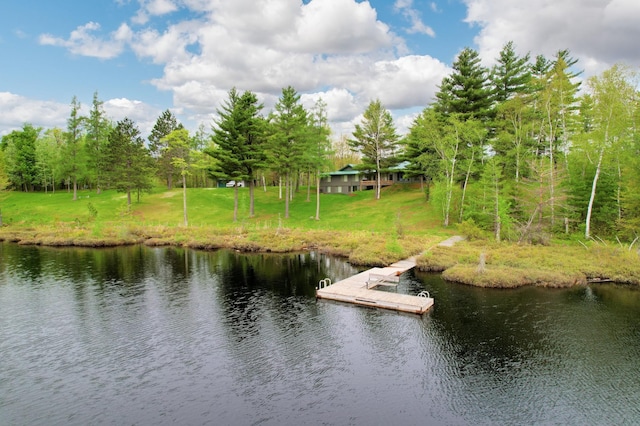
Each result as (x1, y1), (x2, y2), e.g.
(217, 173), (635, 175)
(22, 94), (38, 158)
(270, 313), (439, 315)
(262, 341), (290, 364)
(465, 0), (640, 75)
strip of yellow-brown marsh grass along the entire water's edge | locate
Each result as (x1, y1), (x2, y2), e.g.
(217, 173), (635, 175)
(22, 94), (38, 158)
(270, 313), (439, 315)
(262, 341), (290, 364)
(0, 225), (640, 288)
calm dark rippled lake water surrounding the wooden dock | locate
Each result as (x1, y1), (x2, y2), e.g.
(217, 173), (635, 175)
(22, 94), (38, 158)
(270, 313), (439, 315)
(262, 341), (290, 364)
(0, 244), (640, 425)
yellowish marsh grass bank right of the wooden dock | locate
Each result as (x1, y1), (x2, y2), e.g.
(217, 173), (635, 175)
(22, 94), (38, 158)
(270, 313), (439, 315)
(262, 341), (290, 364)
(417, 241), (640, 288)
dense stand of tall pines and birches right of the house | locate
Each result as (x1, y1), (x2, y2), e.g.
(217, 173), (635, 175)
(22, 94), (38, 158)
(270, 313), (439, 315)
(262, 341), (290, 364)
(403, 43), (640, 243)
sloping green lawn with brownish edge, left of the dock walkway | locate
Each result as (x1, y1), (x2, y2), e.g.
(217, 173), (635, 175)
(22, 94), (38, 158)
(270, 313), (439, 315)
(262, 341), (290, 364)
(0, 186), (452, 266)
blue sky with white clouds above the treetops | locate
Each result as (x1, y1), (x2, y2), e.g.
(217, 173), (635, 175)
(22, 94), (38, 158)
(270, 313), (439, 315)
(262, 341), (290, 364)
(0, 0), (640, 138)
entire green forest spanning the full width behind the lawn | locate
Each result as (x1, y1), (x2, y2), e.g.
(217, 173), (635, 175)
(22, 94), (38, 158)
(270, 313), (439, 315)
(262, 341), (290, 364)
(0, 42), (640, 245)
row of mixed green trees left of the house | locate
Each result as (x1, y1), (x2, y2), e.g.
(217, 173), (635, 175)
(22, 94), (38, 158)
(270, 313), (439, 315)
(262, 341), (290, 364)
(0, 87), (333, 224)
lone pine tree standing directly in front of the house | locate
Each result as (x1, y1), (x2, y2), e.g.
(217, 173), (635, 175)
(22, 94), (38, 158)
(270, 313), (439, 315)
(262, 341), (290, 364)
(349, 99), (398, 199)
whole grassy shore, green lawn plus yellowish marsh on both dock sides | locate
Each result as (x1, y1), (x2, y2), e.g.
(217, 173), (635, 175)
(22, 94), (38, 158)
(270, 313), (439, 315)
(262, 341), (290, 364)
(0, 186), (640, 288)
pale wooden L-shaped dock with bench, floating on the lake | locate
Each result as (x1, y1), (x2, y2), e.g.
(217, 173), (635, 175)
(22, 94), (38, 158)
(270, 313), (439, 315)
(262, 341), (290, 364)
(316, 258), (433, 314)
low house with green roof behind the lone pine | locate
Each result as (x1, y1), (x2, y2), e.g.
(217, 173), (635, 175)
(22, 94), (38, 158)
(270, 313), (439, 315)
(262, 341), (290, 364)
(320, 161), (414, 194)
